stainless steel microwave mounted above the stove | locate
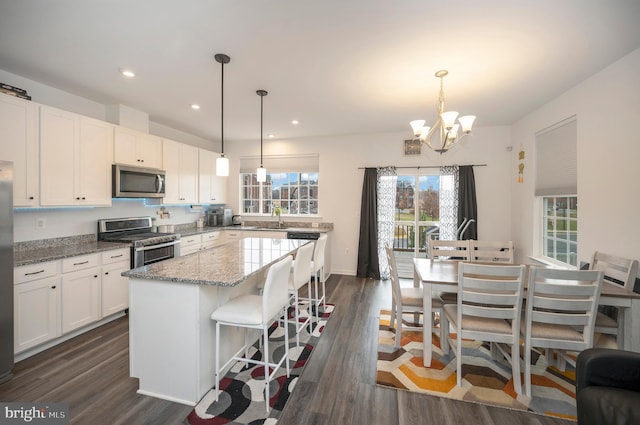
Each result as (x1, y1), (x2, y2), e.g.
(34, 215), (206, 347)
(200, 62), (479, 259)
(112, 164), (165, 198)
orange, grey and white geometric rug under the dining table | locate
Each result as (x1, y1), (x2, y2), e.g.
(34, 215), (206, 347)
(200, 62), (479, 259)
(376, 310), (576, 420)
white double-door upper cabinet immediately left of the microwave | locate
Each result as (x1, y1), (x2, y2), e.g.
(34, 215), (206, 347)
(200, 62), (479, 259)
(40, 106), (113, 206)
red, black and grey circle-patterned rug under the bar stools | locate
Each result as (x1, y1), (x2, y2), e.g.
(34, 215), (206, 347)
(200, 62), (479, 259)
(184, 301), (335, 425)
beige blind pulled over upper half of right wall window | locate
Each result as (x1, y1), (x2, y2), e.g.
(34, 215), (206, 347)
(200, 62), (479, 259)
(535, 116), (578, 196)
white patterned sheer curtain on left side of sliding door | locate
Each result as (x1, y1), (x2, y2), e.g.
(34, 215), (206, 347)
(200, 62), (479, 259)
(377, 167), (398, 279)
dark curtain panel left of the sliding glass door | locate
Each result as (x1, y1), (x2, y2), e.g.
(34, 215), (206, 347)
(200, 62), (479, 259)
(356, 168), (380, 279)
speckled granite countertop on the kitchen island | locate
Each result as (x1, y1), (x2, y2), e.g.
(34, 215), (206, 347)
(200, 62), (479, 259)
(122, 238), (310, 287)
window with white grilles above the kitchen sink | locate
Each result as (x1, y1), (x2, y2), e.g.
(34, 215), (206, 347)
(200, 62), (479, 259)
(240, 171), (318, 215)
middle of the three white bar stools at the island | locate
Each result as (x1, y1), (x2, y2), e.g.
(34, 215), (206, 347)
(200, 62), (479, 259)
(289, 243), (314, 347)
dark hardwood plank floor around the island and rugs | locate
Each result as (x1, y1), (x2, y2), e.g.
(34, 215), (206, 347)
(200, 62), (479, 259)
(0, 275), (575, 425)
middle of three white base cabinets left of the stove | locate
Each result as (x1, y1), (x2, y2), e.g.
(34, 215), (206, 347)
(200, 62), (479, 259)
(61, 254), (101, 333)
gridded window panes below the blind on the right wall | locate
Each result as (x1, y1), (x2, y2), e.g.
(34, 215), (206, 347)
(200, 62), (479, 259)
(542, 196), (578, 267)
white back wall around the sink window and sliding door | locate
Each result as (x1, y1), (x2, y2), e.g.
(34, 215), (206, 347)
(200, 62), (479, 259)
(225, 124), (511, 275)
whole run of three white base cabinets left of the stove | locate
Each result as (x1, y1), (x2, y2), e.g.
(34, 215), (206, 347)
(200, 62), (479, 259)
(13, 248), (130, 354)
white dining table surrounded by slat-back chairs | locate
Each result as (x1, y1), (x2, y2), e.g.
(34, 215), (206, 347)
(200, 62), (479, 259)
(413, 258), (640, 367)
